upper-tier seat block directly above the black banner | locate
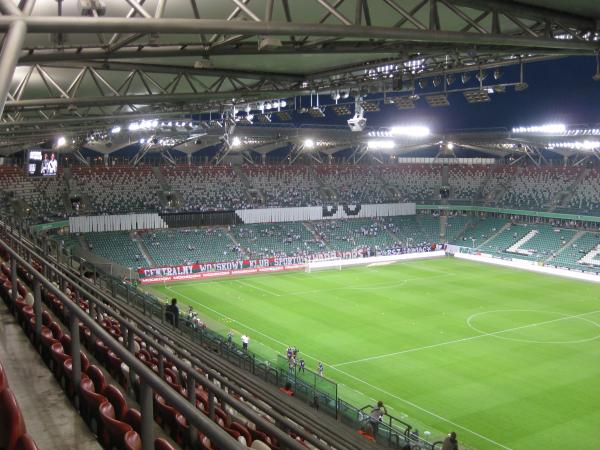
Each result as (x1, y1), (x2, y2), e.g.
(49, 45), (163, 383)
(161, 165), (249, 211)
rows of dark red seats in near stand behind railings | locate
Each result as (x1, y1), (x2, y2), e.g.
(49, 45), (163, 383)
(0, 232), (380, 450)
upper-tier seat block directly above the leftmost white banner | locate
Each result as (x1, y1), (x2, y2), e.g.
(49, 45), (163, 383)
(73, 166), (160, 214)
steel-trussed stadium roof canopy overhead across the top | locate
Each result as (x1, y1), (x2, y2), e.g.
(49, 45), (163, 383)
(0, 0), (600, 151)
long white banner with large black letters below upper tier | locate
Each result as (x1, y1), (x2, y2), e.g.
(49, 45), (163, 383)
(235, 203), (417, 224)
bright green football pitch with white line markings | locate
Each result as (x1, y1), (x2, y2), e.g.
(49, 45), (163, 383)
(145, 258), (600, 450)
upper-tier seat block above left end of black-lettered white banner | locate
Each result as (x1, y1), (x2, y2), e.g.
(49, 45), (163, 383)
(243, 165), (321, 206)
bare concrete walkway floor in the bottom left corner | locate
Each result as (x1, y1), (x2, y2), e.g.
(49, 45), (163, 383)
(0, 302), (102, 450)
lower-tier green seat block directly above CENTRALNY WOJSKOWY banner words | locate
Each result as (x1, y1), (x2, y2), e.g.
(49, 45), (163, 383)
(140, 228), (245, 266)
